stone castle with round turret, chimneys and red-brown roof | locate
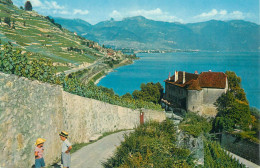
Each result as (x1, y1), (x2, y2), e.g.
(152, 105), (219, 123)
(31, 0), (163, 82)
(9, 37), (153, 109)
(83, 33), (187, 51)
(164, 71), (228, 116)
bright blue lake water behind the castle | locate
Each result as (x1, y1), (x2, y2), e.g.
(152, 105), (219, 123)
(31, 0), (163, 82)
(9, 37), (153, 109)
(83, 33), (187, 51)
(98, 52), (260, 109)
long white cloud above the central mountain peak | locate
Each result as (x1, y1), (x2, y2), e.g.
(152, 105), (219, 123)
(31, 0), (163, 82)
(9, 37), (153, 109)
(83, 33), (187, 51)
(109, 8), (183, 22)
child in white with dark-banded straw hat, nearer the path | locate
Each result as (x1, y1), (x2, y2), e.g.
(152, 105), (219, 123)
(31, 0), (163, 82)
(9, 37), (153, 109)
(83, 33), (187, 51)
(59, 131), (72, 168)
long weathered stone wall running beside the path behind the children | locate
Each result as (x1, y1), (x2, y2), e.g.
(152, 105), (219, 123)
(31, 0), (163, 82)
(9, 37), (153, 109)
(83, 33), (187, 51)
(0, 73), (165, 167)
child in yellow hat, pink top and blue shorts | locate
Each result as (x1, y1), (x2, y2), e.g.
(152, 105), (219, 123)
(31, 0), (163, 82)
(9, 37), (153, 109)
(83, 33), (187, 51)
(34, 138), (46, 168)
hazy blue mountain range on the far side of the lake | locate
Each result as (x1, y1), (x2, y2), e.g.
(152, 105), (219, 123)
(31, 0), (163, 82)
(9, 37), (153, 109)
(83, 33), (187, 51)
(55, 16), (260, 51)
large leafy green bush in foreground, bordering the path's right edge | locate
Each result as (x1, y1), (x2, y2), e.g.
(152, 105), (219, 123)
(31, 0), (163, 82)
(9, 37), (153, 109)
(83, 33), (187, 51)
(103, 120), (193, 168)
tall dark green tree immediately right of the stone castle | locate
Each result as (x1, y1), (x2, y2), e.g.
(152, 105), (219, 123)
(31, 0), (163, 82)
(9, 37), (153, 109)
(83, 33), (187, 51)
(213, 71), (252, 132)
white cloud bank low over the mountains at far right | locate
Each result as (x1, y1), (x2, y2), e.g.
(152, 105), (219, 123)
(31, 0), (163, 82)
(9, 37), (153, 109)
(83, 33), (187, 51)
(194, 9), (246, 21)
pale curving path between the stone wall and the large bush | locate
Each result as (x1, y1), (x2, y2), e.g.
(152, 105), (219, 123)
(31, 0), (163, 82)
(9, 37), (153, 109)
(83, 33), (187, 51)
(71, 131), (131, 168)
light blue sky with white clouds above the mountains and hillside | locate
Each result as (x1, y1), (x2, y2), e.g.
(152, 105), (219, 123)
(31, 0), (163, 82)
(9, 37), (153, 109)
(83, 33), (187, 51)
(13, 0), (260, 24)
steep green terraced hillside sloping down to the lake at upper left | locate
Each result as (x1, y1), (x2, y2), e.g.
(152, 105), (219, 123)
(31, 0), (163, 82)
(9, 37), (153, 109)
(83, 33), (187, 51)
(0, 0), (131, 71)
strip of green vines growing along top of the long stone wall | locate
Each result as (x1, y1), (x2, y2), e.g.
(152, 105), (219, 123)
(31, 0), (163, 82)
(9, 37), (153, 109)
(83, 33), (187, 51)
(0, 45), (162, 110)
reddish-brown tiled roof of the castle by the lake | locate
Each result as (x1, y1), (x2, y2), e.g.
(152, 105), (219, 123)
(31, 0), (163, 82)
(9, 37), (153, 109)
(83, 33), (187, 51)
(164, 71), (227, 90)
